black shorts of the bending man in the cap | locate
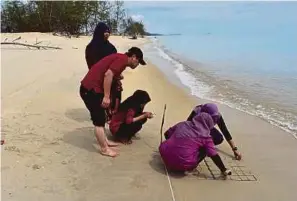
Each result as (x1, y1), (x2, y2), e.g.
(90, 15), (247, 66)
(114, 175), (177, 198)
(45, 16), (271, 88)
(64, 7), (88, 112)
(79, 85), (106, 127)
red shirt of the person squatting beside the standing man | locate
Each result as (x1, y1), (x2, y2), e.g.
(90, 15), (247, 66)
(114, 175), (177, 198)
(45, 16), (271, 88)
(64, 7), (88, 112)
(109, 109), (136, 135)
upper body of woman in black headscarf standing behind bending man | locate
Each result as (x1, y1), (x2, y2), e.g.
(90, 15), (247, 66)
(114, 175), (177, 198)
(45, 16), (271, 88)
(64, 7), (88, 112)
(85, 22), (117, 69)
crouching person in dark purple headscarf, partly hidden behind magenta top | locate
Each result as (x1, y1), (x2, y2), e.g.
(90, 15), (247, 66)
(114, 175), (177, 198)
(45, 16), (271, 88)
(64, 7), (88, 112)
(187, 103), (242, 161)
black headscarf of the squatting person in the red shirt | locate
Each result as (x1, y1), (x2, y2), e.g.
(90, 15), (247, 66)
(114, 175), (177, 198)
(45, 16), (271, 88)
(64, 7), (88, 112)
(119, 90), (151, 114)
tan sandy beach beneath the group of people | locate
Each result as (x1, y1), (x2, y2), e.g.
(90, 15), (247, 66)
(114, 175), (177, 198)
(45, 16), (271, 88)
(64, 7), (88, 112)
(1, 33), (297, 201)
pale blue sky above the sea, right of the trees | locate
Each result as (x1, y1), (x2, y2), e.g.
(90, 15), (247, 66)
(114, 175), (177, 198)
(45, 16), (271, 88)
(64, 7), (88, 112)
(125, 1), (297, 34)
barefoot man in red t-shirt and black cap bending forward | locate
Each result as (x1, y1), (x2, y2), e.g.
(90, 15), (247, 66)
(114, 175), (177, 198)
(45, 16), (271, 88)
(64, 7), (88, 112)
(80, 47), (146, 157)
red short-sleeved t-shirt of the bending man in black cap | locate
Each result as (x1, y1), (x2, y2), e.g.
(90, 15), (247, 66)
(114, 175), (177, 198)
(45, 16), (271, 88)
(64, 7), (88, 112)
(81, 53), (128, 93)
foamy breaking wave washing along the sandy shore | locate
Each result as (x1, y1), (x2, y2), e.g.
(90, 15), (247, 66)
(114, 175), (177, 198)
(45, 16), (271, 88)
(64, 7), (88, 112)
(148, 38), (297, 139)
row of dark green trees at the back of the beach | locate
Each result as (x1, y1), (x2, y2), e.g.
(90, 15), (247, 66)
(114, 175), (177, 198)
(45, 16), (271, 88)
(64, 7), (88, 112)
(1, 1), (146, 36)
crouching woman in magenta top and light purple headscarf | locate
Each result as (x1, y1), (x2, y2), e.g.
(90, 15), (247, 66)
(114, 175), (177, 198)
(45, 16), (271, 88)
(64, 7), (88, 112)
(159, 112), (231, 176)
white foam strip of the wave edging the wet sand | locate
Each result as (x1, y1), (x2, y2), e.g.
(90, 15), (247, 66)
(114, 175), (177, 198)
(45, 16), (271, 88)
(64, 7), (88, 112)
(149, 39), (297, 139)
